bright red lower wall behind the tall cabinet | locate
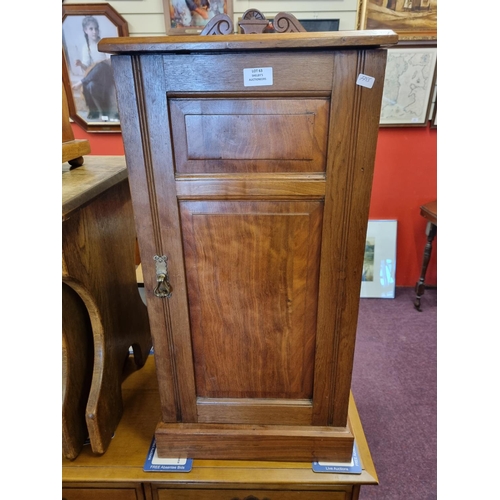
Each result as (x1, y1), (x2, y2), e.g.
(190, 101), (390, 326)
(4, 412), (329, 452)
(72, 123), (437, 287)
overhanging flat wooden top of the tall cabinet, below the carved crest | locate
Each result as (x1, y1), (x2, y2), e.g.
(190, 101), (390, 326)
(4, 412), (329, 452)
(99, 30), (398, 54)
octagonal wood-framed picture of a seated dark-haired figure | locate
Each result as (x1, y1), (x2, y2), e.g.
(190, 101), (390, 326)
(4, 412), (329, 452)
(62, 3), (128, 132)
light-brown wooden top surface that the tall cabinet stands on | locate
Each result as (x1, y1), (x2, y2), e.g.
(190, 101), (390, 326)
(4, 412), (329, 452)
(62, 356), (378, 490)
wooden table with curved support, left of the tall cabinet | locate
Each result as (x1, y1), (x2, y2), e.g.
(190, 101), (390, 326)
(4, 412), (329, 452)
(62, 156), (151, 459)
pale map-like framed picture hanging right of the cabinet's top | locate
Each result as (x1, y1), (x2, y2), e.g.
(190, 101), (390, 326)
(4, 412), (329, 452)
(380, 47), (437, 127)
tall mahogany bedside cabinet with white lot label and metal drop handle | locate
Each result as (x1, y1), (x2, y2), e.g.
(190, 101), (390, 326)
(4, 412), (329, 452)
(99, 24), (397, 460)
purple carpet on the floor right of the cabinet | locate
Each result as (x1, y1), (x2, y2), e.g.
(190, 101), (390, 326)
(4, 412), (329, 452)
(352, 288), (437, 500)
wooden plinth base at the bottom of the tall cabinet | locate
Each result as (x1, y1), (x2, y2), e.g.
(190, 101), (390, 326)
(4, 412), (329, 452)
(155, 422), (354, 462)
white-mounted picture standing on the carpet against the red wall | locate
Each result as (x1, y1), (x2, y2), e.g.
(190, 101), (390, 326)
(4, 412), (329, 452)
(361, 220), (398, 299)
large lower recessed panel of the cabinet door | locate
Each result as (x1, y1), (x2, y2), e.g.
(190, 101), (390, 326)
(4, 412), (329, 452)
(180, 201), (323, 399)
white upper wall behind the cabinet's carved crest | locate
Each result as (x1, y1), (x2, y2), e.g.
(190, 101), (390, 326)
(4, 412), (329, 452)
(64, 0), (358, 36)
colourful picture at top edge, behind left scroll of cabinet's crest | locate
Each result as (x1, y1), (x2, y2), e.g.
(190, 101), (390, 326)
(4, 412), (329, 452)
(163, 0), (233, 35)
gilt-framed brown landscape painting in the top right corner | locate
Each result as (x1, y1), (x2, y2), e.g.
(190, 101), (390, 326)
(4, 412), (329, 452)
(357, 0), (437, 41)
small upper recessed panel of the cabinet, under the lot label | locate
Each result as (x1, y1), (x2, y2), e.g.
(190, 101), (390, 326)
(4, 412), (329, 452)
(168, 97), (329, 174)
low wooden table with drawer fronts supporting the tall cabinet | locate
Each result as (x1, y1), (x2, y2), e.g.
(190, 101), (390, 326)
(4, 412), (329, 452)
(62, 356), (378, 500)
